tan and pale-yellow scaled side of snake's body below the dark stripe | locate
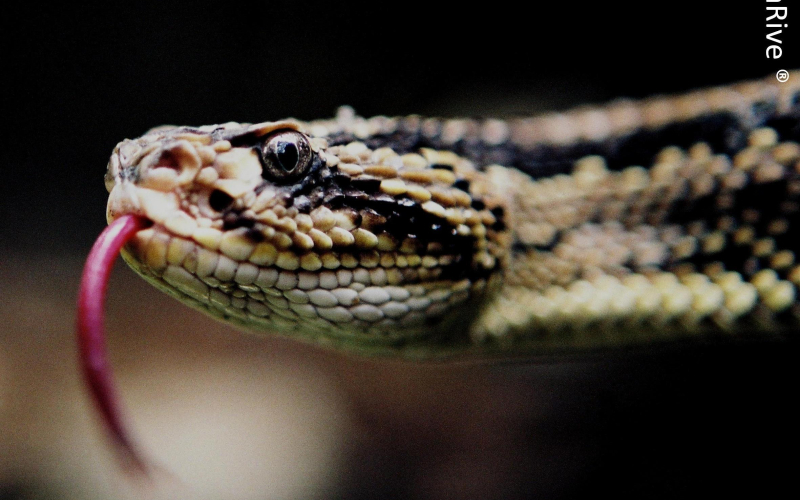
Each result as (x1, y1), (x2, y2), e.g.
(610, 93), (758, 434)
(474, 128), (800, 340)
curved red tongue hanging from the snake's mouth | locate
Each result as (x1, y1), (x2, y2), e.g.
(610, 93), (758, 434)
(77, 215), (151, 472)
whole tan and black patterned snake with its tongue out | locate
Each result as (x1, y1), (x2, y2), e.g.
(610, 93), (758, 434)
(81, 71), (800, 472)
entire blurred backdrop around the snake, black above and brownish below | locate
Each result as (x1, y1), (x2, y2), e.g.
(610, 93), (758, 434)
(0, 0), (800, 500)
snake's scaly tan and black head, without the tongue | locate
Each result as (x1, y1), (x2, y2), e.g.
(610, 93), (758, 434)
(106, 111), (509, 345)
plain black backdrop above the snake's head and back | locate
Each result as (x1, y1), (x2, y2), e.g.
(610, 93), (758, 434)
(0, 0), (800, 251)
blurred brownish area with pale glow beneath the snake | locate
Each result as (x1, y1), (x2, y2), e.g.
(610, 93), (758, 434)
(0, 255), (799, 500)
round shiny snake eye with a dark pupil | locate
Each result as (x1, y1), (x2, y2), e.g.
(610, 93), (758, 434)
(260, 130), (311, 181)
